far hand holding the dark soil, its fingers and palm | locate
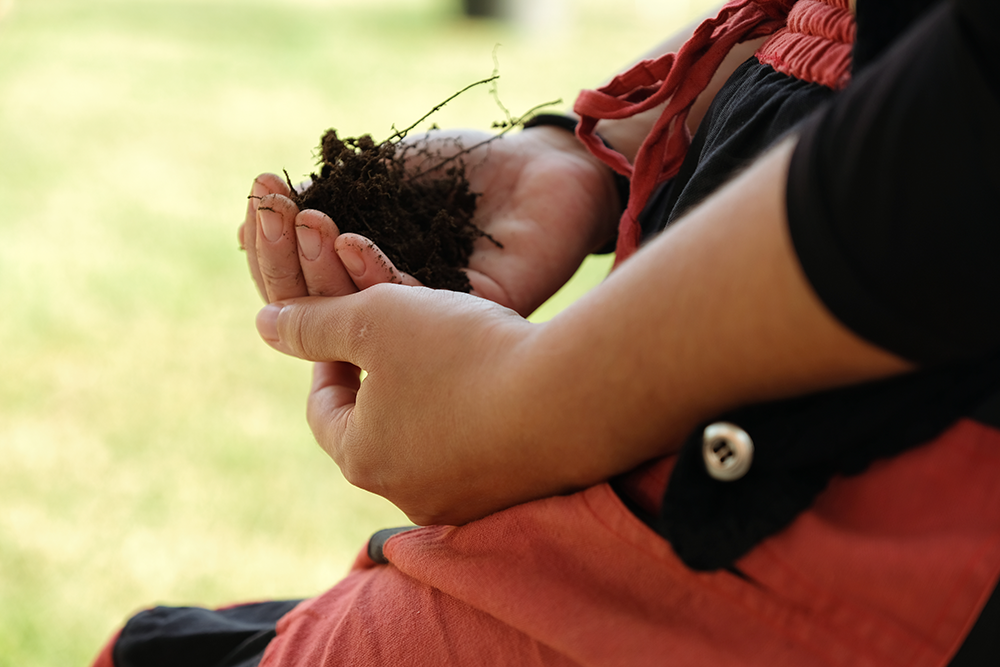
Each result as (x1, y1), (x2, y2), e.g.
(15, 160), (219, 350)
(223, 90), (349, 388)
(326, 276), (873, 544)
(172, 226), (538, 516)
(240, 127), (619, 315)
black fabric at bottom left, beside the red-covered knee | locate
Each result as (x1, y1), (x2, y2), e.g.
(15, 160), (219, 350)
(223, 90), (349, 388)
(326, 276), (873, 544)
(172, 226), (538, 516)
(112, 600), (299, 667)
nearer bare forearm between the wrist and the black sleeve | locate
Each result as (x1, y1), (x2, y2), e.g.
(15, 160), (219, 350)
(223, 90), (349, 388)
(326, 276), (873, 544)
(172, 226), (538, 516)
(508, 141), (910, 486)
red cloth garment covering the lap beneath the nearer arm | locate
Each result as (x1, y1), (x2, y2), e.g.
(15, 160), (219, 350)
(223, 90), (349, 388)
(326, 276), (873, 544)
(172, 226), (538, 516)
(252, 420), (1000, 667)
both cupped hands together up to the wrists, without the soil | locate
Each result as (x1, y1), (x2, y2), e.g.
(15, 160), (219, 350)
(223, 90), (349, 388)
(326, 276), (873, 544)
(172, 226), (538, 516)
(239, 127), (618, 524)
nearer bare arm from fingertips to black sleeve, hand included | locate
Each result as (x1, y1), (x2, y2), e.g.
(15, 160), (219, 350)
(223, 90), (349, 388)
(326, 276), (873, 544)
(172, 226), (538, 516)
(257, 138), (912, 524)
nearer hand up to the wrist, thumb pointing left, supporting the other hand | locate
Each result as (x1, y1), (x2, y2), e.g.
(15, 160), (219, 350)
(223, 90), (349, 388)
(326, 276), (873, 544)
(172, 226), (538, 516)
(257, 284), (572, 525)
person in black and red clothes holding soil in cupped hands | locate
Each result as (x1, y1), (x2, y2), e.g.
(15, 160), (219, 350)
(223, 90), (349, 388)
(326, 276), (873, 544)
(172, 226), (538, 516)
(98, 0), (1000, 667)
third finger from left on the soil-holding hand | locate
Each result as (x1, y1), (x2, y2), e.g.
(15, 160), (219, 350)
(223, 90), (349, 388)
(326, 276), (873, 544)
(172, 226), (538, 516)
(295, 210), (358, 296)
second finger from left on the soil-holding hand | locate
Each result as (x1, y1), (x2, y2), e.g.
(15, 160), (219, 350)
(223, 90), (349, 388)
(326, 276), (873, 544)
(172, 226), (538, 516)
(257, 194), (308, 302)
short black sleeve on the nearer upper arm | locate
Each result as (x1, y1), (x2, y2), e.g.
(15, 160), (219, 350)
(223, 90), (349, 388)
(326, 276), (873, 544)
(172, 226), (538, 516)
(787, 0), (1000, 364)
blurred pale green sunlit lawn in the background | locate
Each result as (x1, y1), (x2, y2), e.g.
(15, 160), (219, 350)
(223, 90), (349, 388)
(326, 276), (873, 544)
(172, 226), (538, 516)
(0, 0), (711, 667)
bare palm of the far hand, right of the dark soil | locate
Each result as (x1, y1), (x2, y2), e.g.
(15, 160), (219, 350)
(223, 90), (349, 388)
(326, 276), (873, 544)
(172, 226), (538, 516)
(396, 126), (623, 316)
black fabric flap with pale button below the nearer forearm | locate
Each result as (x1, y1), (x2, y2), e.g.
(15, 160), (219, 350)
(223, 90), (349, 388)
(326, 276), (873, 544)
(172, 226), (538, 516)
(656, 355), (1000, 570)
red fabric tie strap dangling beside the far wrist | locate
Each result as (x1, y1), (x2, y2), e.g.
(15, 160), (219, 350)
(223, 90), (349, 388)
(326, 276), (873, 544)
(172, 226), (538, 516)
(573, 0), (795, 266)
